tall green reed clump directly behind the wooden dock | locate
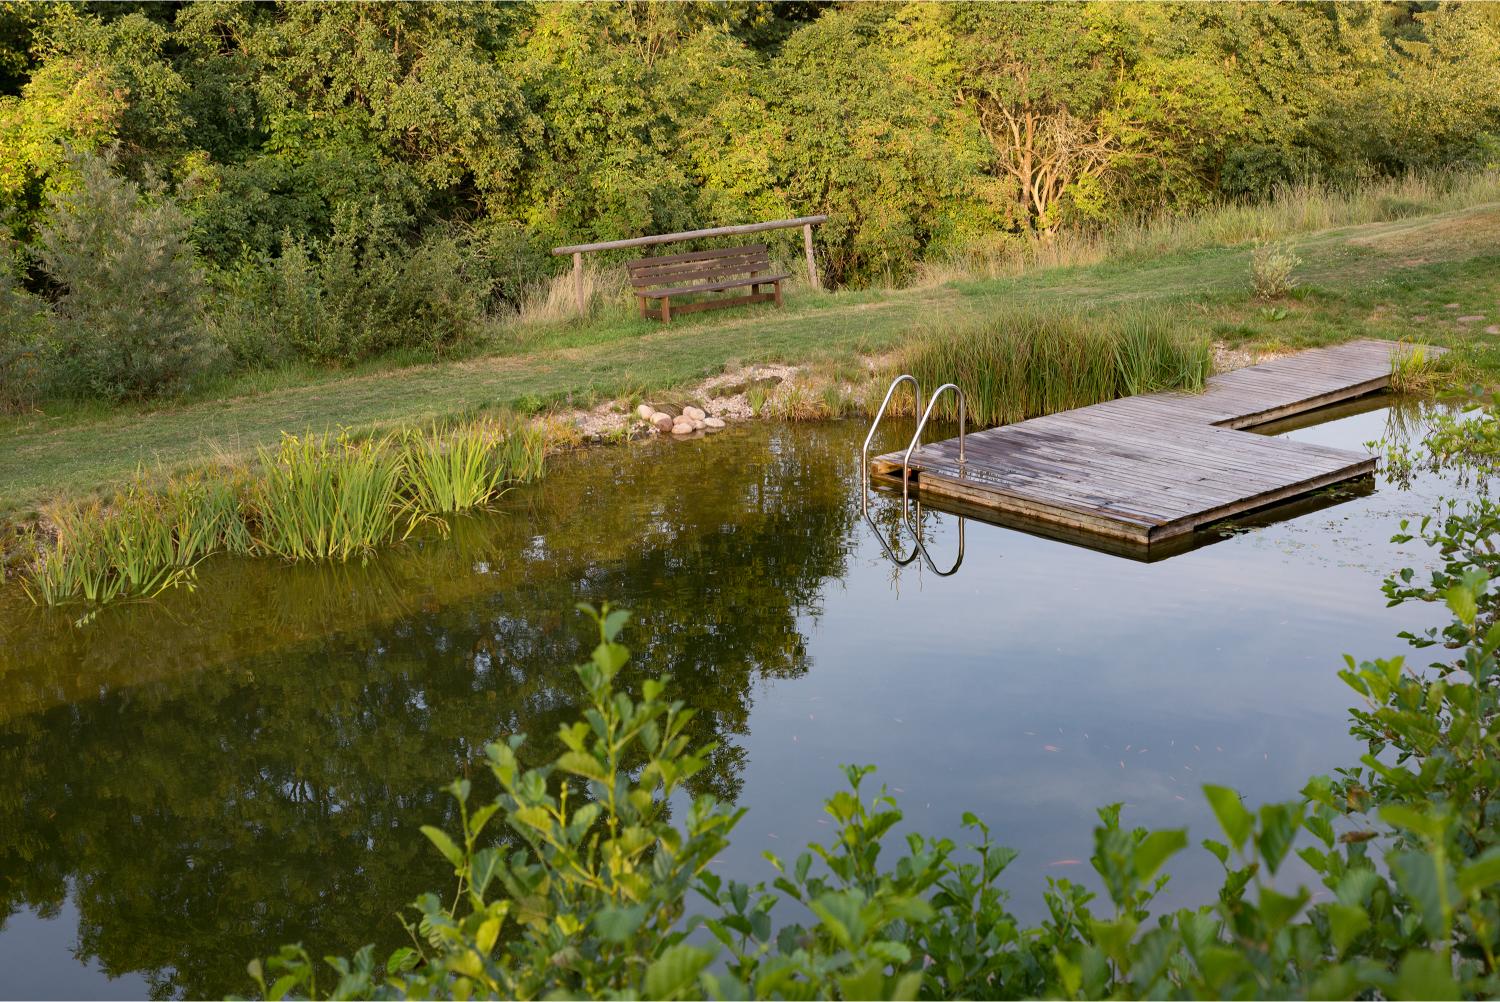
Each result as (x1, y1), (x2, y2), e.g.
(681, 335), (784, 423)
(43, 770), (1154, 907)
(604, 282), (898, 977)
(888, 309), (1214, 426)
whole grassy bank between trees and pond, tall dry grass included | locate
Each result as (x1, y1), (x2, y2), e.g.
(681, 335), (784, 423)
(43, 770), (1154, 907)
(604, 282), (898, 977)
(0, 171), (1500, 513)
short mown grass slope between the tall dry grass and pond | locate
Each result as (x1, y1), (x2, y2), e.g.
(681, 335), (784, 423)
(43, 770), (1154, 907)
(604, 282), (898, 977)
(0, 204), (1500, 515)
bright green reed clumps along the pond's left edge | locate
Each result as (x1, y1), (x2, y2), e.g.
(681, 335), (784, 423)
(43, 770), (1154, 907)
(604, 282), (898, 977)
(23, 419), (548, 621)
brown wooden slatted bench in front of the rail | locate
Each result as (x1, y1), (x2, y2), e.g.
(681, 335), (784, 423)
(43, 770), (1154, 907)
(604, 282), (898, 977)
(626, 243), (792, 324)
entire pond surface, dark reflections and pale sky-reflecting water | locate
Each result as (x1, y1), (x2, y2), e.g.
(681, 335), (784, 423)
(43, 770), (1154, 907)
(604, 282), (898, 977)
(0, 401), (1476, 998)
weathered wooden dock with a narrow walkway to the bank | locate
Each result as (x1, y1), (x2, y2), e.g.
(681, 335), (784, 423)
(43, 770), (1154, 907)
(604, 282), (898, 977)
(870, 341), (1440, 546)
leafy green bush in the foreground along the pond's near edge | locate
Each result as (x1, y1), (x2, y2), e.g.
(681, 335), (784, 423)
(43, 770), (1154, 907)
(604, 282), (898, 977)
(249, 456), (1500, 999)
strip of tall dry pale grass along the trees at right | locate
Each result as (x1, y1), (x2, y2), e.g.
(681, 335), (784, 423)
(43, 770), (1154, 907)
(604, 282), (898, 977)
(915, 170), (1500, 285)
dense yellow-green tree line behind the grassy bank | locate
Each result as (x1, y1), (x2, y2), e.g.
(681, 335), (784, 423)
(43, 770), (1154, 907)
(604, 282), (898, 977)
(0, 2), (1500, 396)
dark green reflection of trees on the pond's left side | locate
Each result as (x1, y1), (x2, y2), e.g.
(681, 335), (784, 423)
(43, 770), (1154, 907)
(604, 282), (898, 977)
(0, 428), (855, 996)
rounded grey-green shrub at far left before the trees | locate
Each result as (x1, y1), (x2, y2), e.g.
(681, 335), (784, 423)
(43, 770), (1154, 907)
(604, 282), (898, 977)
(39, 156), (213, 401)
